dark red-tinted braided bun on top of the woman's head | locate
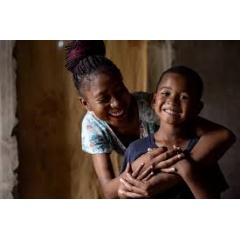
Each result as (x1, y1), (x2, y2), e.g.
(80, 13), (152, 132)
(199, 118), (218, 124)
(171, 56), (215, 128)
(65, 40), (106, 72)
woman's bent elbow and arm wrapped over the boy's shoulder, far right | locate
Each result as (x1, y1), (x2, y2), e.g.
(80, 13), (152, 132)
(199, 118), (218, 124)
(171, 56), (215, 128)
(190, 117), (236, 166)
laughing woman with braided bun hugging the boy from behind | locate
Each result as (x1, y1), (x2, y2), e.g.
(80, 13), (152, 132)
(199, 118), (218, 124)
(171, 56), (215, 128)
(66, 40), (235, 198)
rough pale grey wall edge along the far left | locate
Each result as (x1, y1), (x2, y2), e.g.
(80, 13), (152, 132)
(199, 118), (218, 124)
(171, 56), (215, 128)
(0, 41), (18, 198)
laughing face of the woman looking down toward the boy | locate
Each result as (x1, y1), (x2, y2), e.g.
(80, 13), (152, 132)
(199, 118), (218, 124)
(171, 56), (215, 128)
(80, 73), (131, 127)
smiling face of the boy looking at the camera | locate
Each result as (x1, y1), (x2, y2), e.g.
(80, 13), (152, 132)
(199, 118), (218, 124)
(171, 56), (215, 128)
(152, 73), (202, 124)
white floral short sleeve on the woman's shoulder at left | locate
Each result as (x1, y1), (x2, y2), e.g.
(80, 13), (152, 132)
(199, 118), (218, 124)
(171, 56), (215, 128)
(82, 114), (112, 154)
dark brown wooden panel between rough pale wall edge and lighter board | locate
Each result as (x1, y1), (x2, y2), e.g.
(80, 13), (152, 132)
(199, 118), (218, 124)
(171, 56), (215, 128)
(15, 41), (70, 198)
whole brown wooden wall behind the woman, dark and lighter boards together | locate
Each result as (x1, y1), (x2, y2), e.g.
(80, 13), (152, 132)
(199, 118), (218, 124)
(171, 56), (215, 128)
(15, 40), (147, 198)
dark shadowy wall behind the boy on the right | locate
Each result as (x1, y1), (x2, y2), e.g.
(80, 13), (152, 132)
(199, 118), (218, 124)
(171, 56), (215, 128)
(173, 41), (240, 198)
